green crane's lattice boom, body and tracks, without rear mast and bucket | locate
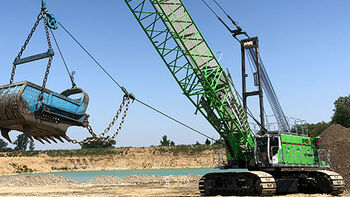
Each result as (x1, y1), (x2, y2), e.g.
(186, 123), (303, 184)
(125, 0), (344, 195)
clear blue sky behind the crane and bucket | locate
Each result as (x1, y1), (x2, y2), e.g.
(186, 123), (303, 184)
(0, 0), (350, 149)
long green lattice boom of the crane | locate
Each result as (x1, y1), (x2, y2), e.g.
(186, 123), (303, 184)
(125, 0), (254, 161)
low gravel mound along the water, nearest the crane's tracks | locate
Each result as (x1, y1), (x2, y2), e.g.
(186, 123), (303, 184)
(88, 175), (201, 185)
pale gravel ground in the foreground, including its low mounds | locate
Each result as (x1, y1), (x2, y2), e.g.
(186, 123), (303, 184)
(0, 175), (350, 197)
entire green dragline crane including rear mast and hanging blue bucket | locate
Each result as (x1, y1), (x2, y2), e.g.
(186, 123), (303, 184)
(0, 0), (345, 195)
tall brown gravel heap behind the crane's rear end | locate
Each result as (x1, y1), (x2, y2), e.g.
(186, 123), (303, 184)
(320, 124), (350, 189)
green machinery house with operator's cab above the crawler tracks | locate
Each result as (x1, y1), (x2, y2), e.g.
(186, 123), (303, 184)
(254, 134), (330, 168)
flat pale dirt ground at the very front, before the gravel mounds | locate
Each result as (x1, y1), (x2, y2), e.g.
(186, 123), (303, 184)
(0, 183), (350, 197)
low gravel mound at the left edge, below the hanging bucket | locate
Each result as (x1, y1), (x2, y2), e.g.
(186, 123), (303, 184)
(0, 175), (77, 187)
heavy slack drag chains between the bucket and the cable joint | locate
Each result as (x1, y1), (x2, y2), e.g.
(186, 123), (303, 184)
(67, 95), (133, 145)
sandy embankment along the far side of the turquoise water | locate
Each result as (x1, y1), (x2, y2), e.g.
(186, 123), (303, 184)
(0, 147), (213, 175)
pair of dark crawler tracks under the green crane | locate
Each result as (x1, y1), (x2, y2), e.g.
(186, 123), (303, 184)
(199, 169), (345, 196)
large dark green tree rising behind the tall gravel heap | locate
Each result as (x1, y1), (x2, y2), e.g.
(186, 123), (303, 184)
(332, 95), (350, 128)
